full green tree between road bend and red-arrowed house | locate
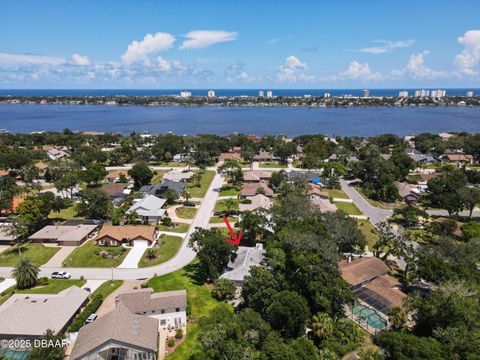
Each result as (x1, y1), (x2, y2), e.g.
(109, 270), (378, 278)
(189, 228), (234, 280)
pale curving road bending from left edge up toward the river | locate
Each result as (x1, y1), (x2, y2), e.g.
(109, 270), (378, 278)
(0, 169), (224, 280)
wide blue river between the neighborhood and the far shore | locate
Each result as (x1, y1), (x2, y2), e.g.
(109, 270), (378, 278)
(0, 105), (480, 136)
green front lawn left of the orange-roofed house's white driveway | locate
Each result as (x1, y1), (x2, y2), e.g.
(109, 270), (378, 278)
(62, 241), (130, 267)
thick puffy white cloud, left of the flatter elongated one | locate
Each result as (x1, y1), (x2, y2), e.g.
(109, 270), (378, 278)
(122, 32), (175, 64)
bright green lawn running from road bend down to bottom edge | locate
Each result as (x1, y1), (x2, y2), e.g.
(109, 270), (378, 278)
(148, 262), (230, 360)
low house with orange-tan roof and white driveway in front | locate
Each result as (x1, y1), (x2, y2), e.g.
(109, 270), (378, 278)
(96, 225), (157, 246)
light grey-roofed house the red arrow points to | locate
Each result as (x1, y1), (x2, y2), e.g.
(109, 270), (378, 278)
(220, 244), (266, 287)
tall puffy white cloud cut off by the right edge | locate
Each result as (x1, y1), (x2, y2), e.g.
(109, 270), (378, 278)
(454, 30), (480, 76)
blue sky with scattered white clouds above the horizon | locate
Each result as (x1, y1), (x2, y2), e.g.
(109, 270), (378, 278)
(0, 0), (480, 89)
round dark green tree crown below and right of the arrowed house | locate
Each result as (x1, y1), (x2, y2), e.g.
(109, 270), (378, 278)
(266, 290), (310, 338)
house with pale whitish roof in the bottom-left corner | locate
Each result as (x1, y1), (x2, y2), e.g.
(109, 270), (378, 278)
(0, 286), (90, 339)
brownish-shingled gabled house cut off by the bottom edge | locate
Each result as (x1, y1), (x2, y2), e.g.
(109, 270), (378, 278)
(69, 304), (159, 360)
